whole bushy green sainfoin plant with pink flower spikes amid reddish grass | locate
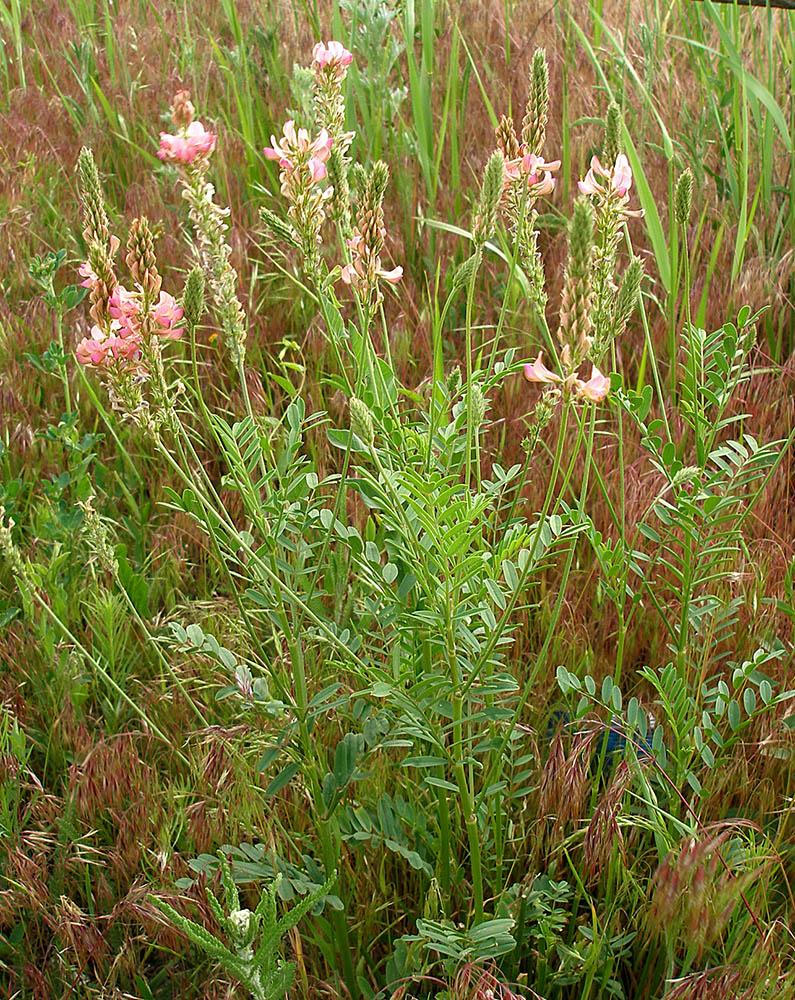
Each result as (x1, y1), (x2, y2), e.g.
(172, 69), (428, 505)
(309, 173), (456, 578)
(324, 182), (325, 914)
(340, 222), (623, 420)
(0, 27), (793, 1000)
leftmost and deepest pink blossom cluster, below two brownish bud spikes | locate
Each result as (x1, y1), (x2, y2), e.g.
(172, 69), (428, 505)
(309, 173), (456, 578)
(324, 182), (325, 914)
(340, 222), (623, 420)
(77, 282), (184, 367)
